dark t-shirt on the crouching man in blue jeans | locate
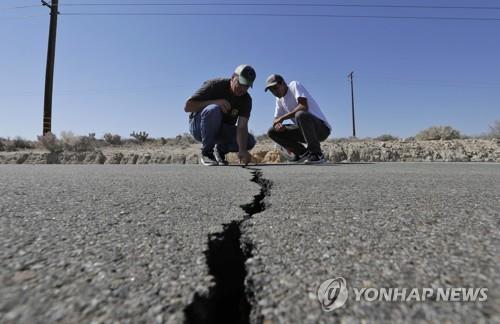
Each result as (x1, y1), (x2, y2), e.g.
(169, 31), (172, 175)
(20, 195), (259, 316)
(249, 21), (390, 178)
(189, 78), (252, 125)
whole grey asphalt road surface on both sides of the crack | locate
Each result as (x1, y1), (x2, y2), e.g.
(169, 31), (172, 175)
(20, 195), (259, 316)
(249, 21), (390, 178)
(0, 163), (500, 324)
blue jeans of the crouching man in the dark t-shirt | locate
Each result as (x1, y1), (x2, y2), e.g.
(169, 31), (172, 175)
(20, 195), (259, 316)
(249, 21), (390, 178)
(189, 105), (255, 154)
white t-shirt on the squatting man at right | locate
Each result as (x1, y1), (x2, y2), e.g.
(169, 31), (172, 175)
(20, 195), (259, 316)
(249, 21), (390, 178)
(274, 81), (332, 129)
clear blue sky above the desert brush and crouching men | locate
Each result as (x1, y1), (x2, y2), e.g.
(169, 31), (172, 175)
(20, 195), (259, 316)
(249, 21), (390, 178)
(0, 0), (500, 139)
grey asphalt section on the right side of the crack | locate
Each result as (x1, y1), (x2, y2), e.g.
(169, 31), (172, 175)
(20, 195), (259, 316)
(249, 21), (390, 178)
(245, 163), (500, 323)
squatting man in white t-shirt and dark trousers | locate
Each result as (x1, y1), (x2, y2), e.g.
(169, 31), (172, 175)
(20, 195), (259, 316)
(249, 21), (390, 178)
(265, 74), (331, 164)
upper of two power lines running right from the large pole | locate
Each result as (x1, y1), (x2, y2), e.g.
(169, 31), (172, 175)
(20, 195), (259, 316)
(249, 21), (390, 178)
(54, 2), (500, 10)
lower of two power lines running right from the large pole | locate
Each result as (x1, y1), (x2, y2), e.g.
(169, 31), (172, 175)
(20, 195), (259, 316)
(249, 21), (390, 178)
(61, 12), (500, 22)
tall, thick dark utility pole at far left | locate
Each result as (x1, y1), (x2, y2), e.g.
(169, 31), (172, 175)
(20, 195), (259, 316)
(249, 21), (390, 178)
(41, 0), (59, 135)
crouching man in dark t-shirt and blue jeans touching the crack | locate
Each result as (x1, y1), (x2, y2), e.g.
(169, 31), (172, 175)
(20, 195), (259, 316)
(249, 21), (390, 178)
(184, 65), (256, 165)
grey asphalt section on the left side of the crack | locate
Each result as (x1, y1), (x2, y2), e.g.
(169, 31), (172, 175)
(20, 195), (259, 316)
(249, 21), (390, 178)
(0, 165), (259, 323)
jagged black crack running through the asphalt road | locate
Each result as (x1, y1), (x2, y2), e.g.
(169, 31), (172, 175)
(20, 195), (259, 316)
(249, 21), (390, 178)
(184, 167), (273, 324)
